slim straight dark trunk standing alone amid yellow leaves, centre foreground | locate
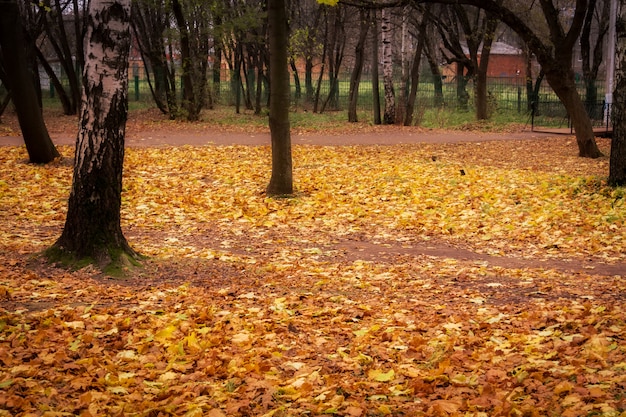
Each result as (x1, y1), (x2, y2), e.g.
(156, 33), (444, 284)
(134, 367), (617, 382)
(266, 0), (293, 196)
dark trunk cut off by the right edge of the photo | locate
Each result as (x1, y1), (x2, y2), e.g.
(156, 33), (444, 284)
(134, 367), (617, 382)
(609, 3), (626, 186)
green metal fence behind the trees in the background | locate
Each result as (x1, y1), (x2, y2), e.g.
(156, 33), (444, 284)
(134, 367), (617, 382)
(26, 66), (609, 127)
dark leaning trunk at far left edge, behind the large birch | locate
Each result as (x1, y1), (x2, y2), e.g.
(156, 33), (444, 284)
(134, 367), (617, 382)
(0, 2), (59, 164)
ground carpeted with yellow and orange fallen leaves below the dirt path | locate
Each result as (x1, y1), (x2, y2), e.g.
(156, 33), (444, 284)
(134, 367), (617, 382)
(0, 132), (626, 417)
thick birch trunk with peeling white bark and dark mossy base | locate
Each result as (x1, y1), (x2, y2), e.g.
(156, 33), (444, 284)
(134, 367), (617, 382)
(48, 0), (136, 272)
